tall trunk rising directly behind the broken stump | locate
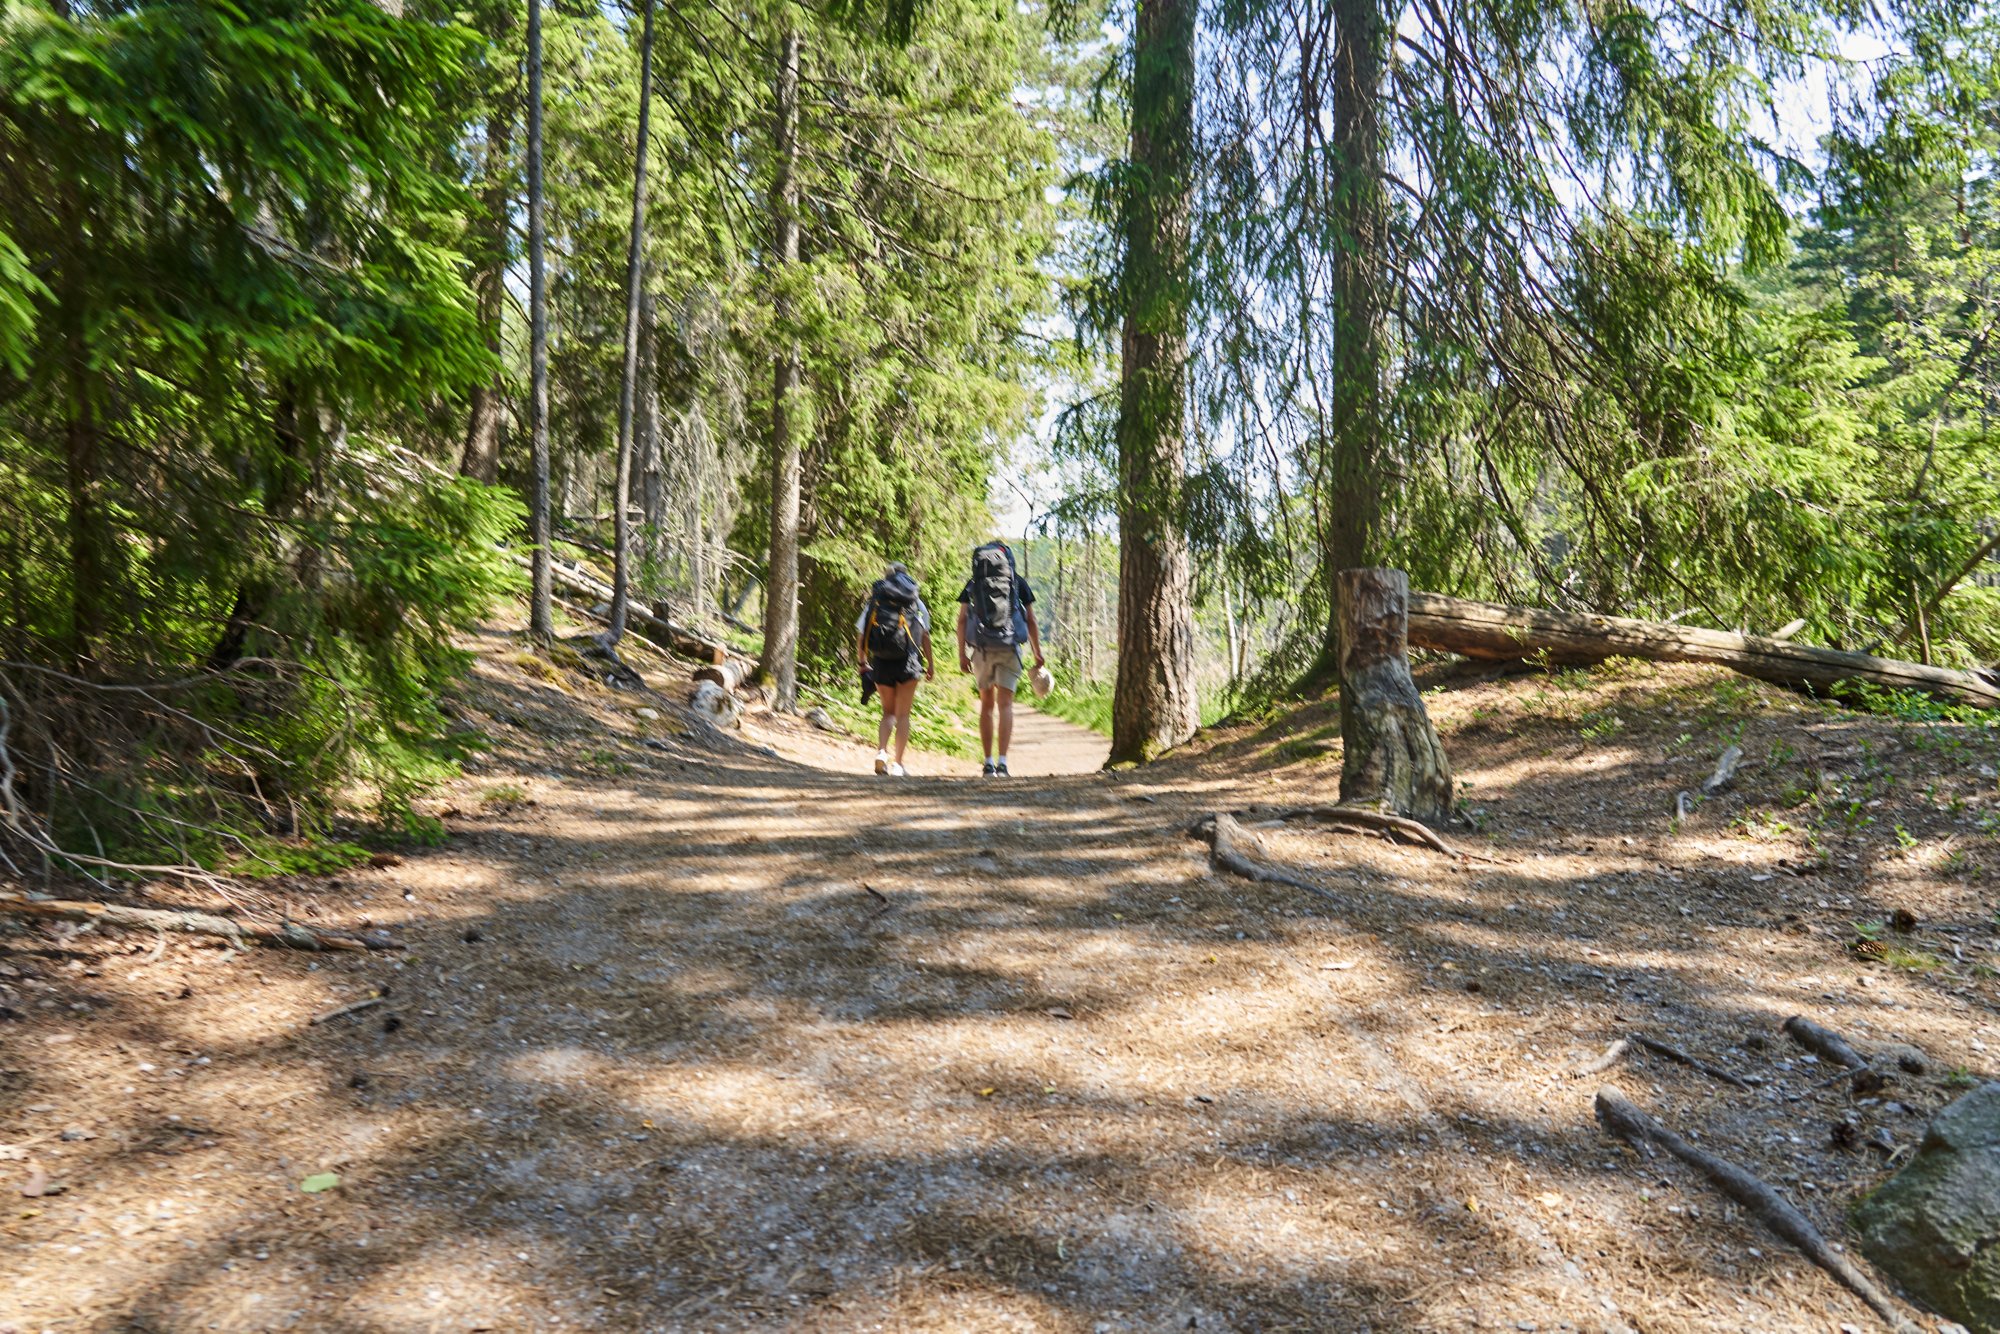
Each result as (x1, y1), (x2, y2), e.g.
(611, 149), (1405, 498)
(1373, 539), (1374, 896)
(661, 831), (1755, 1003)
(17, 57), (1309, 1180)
(1320, 0), (1388, 666)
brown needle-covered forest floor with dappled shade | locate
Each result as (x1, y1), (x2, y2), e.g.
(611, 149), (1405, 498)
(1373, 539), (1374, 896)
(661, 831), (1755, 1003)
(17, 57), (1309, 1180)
(0, 630), (2000, 1334)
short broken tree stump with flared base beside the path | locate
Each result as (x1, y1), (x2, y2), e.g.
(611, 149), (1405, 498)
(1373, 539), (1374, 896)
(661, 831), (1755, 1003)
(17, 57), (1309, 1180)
(1334, 568), (1452, 822)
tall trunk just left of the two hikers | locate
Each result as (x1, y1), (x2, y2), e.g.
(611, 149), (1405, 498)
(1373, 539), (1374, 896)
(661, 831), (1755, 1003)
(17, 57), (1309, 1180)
(758, 28), (800, 712)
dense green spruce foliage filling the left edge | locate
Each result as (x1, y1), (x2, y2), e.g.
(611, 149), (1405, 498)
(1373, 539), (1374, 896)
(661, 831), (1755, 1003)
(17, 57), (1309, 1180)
(0, 0), (520, 864)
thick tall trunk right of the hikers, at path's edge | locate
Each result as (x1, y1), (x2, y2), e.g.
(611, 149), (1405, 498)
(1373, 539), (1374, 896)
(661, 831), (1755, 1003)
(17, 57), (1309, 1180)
(1110, 0), (1200, 762)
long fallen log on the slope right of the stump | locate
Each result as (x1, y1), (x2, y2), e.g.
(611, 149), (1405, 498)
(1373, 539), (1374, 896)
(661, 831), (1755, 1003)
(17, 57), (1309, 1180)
(1410, 592), (2000, 708)
